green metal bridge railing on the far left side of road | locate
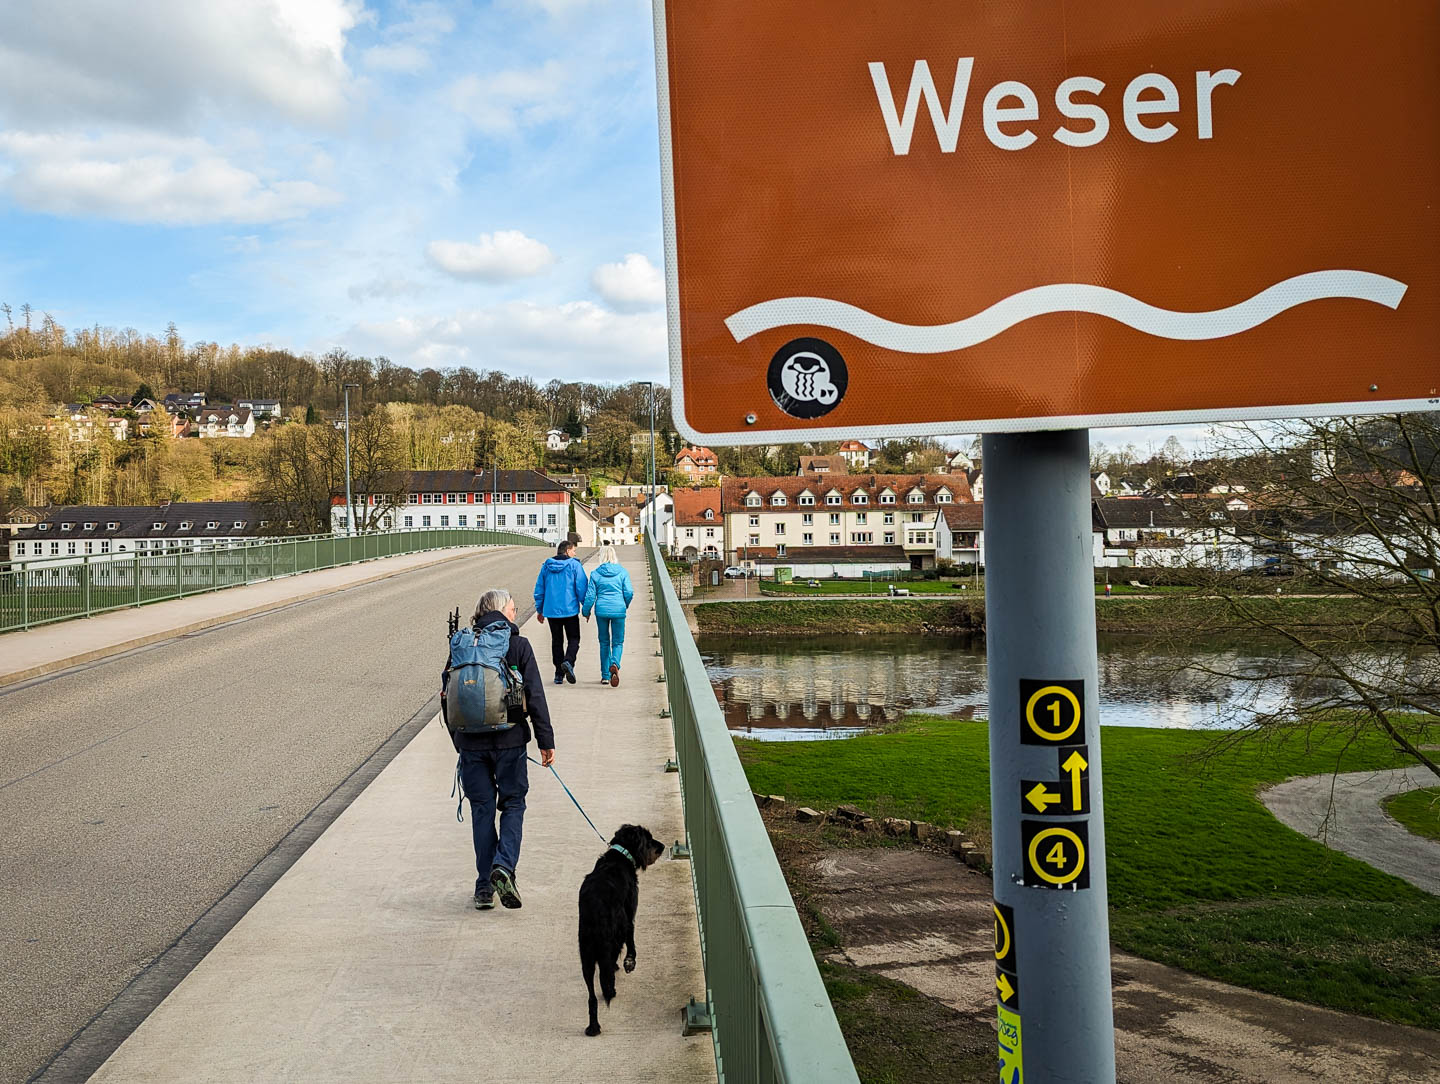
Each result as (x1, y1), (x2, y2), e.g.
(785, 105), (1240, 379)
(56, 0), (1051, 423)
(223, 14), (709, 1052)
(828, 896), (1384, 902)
(0, 527), (549, 632)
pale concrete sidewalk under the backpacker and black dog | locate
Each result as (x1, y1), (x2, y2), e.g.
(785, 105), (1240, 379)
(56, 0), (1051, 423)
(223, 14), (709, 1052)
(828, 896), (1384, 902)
(91, 547), (716, 1084)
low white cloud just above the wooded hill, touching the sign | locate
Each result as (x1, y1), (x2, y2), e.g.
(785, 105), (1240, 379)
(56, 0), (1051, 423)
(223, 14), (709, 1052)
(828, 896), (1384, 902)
(347, 301), (667, 380)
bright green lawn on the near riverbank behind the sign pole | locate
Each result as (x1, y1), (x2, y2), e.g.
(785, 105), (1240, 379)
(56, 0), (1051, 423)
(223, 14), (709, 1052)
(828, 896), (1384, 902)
(740, 717), (1440, 1028)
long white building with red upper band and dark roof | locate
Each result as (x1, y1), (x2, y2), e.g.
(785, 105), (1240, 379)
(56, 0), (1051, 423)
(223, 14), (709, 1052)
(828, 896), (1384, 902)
(330, 471), (570, 543)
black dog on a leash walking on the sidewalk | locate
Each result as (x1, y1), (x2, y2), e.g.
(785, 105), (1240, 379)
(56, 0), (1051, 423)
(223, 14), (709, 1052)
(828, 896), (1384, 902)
(580, 825), (665, 1035)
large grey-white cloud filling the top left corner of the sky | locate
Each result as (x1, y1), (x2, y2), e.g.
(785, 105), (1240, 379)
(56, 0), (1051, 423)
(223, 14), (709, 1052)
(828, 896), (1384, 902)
(0, 0), (363, 128)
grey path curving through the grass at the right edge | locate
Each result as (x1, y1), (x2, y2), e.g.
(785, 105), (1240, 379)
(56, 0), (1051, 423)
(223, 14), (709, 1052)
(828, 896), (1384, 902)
(1260, 767), (1440, 895)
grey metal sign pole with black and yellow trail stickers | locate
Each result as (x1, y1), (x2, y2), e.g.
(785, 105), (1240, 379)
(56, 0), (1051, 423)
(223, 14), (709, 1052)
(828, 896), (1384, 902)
(982, 429), (1115, 1084)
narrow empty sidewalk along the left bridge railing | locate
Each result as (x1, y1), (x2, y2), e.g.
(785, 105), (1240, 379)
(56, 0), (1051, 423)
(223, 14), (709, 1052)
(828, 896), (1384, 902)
(0, 546), (489, 685)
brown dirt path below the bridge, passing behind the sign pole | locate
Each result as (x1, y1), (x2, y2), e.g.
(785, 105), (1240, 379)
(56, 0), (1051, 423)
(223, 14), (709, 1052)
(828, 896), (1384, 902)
(806, 848), (1440, 1084)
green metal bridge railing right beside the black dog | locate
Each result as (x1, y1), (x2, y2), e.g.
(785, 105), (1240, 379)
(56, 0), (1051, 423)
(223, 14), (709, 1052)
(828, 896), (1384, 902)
(645, 538), (860, 1084)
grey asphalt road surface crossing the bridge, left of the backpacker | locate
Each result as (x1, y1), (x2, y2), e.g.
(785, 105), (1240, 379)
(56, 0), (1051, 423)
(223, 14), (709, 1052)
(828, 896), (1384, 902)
(0, 548), (546, 1081)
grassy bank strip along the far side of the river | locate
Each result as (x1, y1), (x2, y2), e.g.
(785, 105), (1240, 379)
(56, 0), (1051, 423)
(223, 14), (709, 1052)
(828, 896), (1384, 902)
(696, 593), (1385, 636)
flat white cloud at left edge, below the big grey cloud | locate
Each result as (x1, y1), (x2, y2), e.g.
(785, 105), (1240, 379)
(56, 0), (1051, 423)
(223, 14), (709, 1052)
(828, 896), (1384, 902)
(0, 132), (340, 226)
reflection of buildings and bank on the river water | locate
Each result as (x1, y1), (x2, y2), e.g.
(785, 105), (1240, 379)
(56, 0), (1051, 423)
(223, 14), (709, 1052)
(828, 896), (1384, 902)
(700, 635), (1293, 740)
